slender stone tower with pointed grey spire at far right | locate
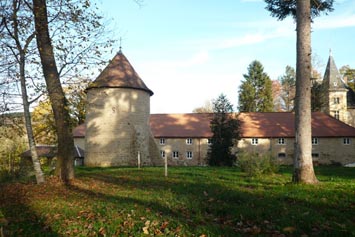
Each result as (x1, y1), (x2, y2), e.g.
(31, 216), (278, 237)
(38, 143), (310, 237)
(323, 54), (348, 123)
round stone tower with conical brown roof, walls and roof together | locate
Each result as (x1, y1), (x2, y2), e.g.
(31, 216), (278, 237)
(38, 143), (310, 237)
(85, 50), (153, 167)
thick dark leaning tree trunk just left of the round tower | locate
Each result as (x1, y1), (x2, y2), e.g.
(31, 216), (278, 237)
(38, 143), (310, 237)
(33, 0), (74, 183)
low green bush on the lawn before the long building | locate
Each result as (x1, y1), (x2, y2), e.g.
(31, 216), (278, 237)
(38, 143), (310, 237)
(238, 151), (279, 177)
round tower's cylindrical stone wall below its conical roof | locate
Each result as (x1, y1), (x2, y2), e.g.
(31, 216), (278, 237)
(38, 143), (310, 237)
(85, 88), (151, 166)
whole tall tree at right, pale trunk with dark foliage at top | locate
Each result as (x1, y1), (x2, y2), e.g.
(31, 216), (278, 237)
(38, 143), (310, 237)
(265, 0), (333, 184)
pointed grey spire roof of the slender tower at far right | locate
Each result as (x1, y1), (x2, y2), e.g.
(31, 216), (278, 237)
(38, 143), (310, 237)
(323, 55), (347, 90)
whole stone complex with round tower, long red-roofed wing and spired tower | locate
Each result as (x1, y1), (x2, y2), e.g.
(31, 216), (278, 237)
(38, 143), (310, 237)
(73, 51), (355, 166)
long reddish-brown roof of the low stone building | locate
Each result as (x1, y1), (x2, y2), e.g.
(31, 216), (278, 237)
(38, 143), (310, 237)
(73, 112), (355, 138)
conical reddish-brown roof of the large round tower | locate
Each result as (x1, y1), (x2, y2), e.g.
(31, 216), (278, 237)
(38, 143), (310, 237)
(87, 50), (153, 96)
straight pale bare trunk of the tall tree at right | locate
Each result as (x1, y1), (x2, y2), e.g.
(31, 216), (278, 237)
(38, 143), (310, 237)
(293, 0), (318, 184)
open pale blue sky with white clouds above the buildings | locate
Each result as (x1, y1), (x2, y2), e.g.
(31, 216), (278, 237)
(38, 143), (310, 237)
(97, 0), (355, 113)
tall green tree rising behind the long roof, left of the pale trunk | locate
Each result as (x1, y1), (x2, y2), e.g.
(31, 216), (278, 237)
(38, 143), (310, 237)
(238, 60), (273, 112)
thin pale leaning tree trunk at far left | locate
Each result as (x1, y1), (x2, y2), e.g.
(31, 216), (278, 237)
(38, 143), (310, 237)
(19, 49), (44, 184)
